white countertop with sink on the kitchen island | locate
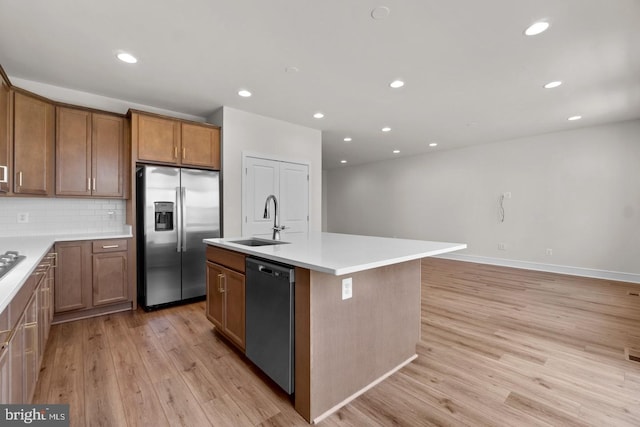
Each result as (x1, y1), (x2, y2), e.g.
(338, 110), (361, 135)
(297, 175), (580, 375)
(204, 233), (467, 276)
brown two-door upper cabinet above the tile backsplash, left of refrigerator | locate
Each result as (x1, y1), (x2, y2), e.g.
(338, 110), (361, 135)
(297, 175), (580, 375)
(56, 107), (126, 198)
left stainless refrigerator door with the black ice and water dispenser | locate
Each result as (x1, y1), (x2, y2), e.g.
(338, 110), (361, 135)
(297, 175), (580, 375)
(144, 166), (182, 306)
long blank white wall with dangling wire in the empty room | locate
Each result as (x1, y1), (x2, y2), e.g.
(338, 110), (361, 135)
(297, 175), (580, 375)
(325, 120), (640, 280)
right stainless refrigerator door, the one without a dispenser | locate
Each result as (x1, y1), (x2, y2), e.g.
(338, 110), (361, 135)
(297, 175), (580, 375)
(180, 169), (220, 299)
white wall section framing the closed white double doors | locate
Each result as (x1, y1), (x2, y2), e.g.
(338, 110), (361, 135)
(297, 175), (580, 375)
(209, 107), (322, 237)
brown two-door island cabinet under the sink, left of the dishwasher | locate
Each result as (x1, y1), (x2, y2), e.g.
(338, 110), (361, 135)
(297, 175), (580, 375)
(206, 246), (245, 351)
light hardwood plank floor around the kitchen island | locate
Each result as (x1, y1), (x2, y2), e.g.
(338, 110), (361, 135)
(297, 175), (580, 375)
(34, 259), (640, 427)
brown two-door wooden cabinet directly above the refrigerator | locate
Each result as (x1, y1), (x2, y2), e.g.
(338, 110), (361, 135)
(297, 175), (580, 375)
(131, 112), (220, 170)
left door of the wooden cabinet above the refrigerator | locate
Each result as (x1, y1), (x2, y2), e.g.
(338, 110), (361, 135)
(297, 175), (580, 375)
(133, 113), (180, 164)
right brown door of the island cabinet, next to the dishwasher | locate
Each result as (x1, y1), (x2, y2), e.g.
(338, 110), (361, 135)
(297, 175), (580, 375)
(224, 269), (245, 350)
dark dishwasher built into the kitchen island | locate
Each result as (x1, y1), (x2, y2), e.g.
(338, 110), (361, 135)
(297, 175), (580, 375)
(245, 257), (295, 394)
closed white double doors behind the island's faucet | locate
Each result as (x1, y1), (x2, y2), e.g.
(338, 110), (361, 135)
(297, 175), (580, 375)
(242, 156), (309, 238)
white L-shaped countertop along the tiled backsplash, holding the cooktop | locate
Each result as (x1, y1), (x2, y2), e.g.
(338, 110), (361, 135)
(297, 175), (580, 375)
(0, 226), (133, 312)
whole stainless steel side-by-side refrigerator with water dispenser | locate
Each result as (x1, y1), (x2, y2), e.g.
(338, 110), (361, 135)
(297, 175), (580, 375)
(136, 166), (220, 309)
